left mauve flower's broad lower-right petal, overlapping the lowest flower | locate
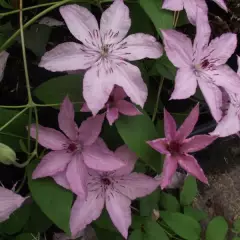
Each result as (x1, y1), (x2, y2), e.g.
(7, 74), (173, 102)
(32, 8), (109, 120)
(82, 138), (124, 171)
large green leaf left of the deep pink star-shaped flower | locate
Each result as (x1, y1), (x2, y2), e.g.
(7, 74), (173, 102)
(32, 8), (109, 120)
(116, 113), (162, 173)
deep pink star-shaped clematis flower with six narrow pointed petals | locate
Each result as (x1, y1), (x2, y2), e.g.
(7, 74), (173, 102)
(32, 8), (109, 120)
(147, 105), (217, 189)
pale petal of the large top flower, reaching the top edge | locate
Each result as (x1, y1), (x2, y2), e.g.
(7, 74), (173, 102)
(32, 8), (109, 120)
(100, 0), (131, 44)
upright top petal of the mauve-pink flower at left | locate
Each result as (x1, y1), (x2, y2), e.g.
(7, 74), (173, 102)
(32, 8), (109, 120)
(58, 96), (78, 140)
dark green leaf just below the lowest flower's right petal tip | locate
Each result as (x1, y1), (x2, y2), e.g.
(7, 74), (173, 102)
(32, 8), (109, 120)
(140, 189), (160, 216)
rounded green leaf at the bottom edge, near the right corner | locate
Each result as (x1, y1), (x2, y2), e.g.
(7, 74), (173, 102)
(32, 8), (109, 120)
(206, 217), (228, 240)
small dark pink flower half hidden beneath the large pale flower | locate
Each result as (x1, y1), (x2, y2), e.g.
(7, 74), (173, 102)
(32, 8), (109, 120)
(81, 86), (142, 125)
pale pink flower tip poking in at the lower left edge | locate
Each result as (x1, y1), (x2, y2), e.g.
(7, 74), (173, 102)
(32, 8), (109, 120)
(0, 187), (26, 222)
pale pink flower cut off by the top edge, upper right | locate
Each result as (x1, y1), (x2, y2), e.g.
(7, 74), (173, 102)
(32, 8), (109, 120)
(162, 0), (228, 25)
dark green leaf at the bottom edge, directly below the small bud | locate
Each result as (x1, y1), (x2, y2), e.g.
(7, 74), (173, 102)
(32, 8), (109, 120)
(144, 221), (169, 240)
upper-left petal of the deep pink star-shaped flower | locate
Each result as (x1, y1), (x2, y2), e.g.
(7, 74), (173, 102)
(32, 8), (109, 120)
(164, 108), (177, 141)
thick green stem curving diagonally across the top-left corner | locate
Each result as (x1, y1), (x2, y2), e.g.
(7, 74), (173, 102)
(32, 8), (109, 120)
(0, 0), (72, 51)
